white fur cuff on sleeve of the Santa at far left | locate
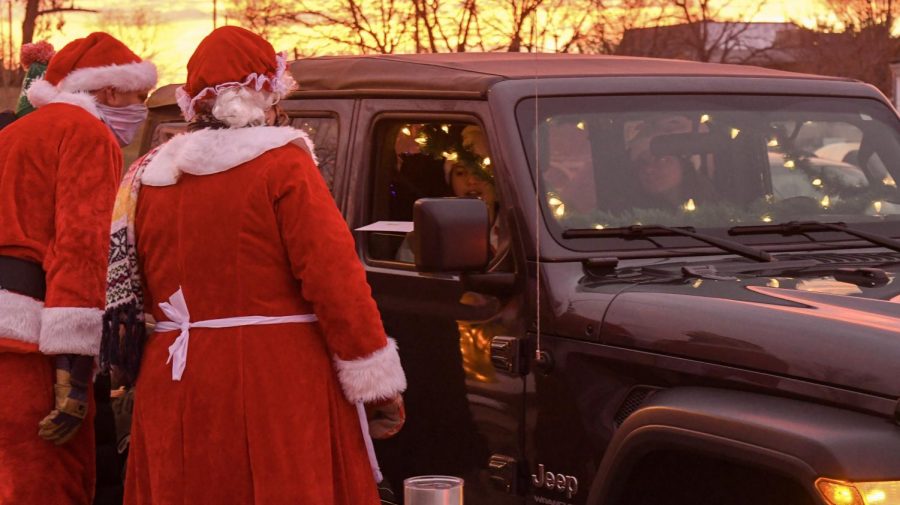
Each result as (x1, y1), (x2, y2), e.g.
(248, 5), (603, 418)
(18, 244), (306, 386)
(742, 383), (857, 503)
(40, 307), (103, 356)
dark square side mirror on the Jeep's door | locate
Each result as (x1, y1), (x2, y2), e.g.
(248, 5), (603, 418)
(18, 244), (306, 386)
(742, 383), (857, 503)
(413, 198), (490, 272)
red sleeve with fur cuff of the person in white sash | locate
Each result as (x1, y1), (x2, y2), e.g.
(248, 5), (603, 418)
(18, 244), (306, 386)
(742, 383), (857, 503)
(270, 146), (406, 402)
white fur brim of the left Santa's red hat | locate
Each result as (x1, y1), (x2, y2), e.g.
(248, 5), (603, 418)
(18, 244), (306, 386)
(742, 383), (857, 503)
(58, 61), (157, 92)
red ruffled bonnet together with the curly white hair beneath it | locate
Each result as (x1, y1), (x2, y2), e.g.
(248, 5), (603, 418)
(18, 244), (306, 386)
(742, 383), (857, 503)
(176, 26), (297, 127)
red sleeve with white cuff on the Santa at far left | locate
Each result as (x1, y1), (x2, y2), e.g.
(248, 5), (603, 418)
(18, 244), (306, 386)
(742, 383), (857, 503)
(40, 120), (122, 356)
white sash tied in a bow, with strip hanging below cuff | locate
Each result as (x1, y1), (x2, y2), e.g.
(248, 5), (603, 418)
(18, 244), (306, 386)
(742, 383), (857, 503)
(156, 287), (382, 482)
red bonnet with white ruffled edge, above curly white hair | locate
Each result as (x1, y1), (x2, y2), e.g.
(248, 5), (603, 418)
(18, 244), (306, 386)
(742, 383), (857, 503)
(176, 26), (296, 121)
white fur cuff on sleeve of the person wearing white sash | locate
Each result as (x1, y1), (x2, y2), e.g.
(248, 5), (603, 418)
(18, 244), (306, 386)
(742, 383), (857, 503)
(334, 338), (406, 403)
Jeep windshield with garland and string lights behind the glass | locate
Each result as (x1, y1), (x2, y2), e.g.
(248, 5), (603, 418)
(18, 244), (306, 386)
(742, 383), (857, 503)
(517, 95), (900, 249)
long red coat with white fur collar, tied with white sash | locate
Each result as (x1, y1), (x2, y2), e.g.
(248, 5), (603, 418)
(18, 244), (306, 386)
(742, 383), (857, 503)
(125, 127), (405, 505)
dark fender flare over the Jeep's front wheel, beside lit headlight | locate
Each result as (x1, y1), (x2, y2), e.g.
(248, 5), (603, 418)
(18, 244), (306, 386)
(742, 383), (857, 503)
(587, 387), (900, 504)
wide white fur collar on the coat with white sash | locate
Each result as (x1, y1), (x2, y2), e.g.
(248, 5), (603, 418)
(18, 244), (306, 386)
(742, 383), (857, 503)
(141, 126), (316, 186)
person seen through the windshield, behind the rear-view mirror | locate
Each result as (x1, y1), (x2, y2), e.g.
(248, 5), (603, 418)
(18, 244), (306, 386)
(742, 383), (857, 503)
(627, 115), (716, 209)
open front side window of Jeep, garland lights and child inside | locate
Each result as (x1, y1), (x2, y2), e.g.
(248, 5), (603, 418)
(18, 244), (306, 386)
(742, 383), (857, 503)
(367, 120), (499, 264)
